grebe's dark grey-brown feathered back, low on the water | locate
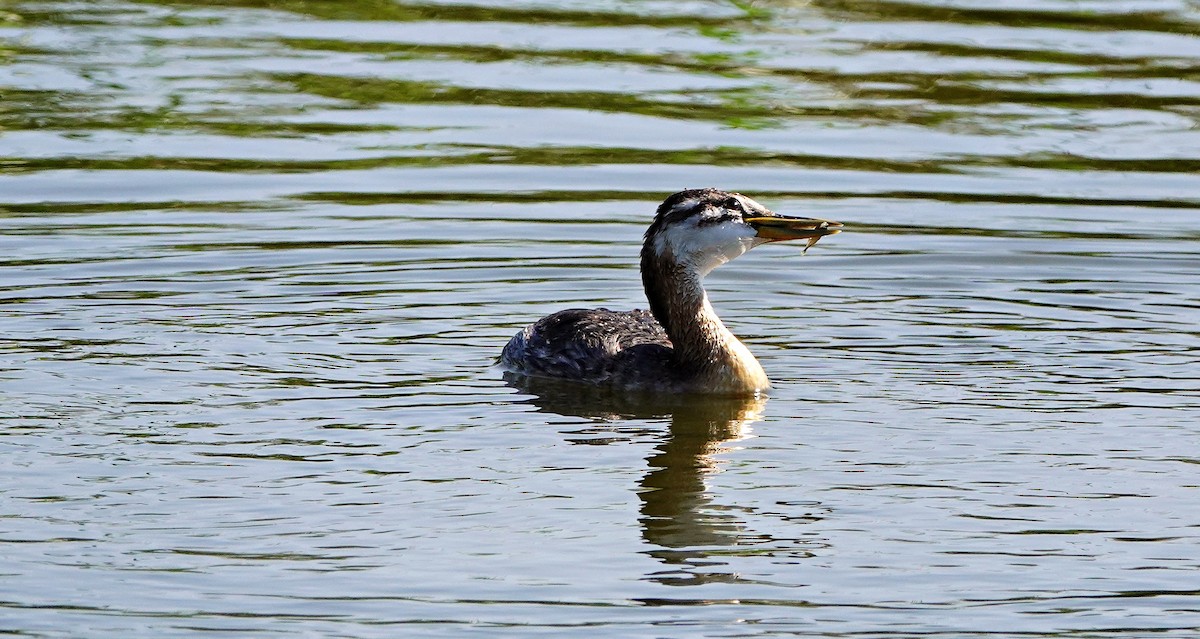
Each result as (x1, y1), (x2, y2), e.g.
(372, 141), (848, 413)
(500, 309), (672, 386)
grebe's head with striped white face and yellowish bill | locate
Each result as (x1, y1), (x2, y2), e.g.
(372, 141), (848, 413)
(642, 189), (841, 277)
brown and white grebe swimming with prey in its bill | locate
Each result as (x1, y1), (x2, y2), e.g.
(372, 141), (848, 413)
(499, 189), (841, 395)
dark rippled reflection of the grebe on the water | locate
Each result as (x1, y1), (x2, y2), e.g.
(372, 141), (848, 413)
(505, 375), (767, 585)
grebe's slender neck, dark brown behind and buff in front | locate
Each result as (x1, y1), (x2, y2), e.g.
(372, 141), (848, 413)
(642, 251), (770, 395)
